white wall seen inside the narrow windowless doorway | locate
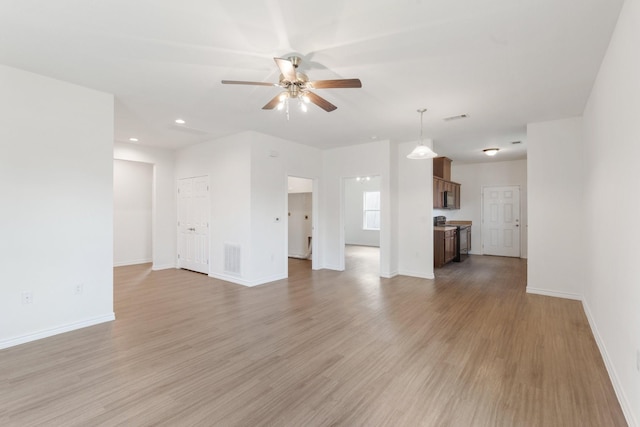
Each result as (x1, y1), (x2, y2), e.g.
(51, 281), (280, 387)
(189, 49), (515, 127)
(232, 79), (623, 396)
(287, 193), (313, 258)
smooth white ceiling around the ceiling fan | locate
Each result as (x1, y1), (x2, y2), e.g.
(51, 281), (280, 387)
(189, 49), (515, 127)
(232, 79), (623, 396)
(0, 0), (623, 162)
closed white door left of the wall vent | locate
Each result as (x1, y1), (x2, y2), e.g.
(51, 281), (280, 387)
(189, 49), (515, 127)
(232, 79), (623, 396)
(178, 176), (209, 274)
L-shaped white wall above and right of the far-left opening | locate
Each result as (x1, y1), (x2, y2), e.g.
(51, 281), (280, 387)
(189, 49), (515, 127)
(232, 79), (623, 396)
(113, 142), (177, 270)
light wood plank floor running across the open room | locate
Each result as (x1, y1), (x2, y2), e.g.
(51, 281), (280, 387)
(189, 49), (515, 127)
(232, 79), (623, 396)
(0, 253), (626, 426)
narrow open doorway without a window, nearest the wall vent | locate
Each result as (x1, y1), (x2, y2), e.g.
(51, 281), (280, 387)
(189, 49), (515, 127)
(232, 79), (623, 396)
(287, 176), (314, 269)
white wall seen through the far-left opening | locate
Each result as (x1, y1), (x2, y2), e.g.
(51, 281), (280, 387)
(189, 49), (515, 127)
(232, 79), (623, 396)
(113, 160), (153, 267)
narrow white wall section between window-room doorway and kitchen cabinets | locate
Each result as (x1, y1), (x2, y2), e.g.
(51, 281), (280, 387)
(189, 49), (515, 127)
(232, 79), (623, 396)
(397, 142), (434, 279)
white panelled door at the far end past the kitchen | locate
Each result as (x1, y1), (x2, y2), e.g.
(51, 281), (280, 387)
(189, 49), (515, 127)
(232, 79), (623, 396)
(482, 185), (520, 257)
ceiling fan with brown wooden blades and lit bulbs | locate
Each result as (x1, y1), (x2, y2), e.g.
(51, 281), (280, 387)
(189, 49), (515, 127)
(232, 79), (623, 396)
(222, 56), (362, 112)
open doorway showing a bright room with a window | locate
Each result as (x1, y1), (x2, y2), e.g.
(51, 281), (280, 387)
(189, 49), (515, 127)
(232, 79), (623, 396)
(343, 175), (381, 275)
